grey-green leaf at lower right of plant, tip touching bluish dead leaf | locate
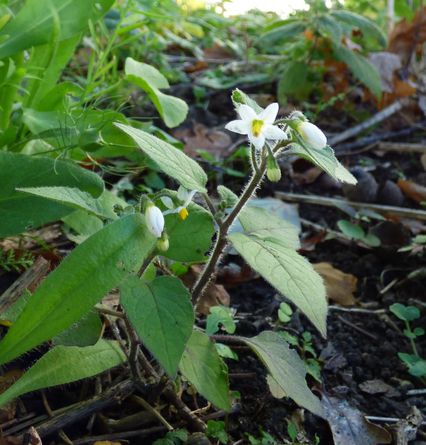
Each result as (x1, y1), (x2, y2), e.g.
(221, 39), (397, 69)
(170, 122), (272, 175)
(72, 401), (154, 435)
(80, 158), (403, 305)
(241, 331), (324, 417)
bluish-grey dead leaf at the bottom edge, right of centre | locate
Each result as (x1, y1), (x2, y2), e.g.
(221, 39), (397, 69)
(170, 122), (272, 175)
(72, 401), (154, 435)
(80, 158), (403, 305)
(321, 395), (392, 445)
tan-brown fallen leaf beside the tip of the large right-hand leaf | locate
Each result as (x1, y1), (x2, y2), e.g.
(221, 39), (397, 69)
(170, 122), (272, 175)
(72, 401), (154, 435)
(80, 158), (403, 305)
(314, 263), (358, 306)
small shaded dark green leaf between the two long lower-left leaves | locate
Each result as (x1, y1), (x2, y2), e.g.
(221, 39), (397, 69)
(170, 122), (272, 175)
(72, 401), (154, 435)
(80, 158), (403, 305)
(53, 310), (103, 347)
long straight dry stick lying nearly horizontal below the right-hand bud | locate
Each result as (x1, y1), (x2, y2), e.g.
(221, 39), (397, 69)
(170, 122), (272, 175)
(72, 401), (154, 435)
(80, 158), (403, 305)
(275, 192), (426, 221)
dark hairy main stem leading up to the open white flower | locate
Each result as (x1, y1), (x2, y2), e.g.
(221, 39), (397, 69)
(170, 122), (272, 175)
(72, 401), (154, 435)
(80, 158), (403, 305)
(192, 154), (266, 306)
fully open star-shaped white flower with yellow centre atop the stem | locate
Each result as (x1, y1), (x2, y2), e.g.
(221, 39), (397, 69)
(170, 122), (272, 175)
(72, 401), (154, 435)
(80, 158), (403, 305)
(225, 102), (287, 150)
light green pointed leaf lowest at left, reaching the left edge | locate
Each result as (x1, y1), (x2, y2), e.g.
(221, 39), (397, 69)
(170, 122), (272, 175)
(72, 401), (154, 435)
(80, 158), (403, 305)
(0, 340), (126, 406)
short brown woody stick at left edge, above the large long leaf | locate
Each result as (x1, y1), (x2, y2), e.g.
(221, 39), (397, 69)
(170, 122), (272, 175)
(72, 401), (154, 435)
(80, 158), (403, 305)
(0, 256), (49, 314)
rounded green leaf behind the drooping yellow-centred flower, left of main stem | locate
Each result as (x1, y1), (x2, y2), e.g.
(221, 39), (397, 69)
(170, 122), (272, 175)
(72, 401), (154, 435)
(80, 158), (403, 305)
(162, 203), (215, 262)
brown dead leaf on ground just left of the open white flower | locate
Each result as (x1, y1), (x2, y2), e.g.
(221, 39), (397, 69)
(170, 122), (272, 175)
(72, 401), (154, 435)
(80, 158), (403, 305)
(173, 123), (232, 158)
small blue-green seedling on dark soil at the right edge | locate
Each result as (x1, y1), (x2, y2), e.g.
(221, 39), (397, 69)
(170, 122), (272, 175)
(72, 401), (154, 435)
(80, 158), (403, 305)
(389, 303), (426, 380)
